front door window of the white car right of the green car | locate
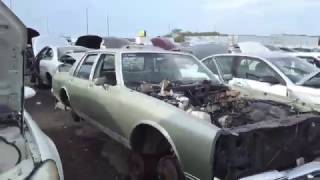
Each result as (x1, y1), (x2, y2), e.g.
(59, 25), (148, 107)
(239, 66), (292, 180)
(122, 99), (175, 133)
(235, 57), (277, 80)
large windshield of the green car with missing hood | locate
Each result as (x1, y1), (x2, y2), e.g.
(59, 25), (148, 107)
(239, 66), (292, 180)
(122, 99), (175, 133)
(122, 53), (219, 86)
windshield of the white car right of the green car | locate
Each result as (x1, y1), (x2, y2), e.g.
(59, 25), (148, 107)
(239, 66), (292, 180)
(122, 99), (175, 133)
(269, 57), (319, 83)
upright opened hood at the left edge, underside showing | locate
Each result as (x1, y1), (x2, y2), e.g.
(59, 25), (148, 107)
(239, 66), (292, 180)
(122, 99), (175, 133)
(0, 1), (27, 112)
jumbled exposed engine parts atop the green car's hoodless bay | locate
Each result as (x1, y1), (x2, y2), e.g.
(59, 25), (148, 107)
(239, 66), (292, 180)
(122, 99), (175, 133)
(139, 80), (297, 128)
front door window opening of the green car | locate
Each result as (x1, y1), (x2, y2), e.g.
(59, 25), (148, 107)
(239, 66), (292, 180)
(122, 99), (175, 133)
(94, 54), (117, 86)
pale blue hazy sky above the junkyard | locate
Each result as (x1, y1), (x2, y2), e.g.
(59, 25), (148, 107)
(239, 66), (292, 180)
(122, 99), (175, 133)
(3, 0), (320, 37)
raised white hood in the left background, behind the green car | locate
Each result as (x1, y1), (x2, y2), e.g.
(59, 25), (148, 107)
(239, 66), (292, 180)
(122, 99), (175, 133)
(32, 36), (69, 56)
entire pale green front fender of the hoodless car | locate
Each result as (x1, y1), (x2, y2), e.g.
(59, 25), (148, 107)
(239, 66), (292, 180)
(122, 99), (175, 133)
(115, 88), (219, 179)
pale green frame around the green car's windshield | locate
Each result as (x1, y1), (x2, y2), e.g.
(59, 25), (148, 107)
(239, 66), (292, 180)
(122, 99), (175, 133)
(118, 51), (222, 87)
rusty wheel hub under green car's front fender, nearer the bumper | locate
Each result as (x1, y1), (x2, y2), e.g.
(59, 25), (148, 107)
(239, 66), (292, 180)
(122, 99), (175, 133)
(157, 155), (185, 180)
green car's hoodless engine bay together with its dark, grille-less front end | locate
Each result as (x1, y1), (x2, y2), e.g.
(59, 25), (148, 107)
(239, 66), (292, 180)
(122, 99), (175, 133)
(137, 81), (320, 180)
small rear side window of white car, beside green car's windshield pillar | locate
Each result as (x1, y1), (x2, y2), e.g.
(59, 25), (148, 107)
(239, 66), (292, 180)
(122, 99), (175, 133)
(214, 56), (234, 80)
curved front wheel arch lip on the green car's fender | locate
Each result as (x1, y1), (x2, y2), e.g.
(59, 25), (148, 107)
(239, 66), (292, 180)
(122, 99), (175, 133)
(129, 121), (181, 164)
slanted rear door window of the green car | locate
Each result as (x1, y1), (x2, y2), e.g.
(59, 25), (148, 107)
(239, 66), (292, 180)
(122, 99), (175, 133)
(75, 54), (97, 79)
